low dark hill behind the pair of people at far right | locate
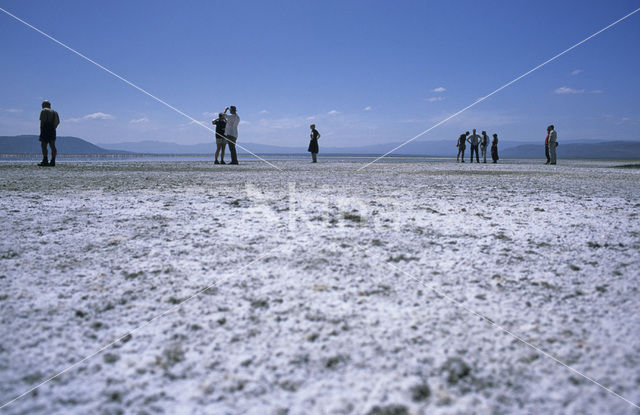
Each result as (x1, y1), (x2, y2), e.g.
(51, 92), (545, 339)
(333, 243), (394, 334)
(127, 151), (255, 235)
(500, 141), (640, 160)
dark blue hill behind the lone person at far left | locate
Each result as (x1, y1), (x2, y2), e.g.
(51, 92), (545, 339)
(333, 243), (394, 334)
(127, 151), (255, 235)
(0, 135), (130, 154)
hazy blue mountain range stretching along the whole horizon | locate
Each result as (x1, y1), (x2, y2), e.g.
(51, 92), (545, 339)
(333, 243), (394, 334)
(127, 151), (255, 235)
(0, 135), (640, 159)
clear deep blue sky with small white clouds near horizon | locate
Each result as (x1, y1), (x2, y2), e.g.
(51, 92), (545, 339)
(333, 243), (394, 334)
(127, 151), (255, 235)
(0, 0), (640, 147)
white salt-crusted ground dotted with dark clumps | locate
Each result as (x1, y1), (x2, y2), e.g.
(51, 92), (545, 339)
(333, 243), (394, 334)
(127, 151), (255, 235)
(0, 161), (640, 414)
